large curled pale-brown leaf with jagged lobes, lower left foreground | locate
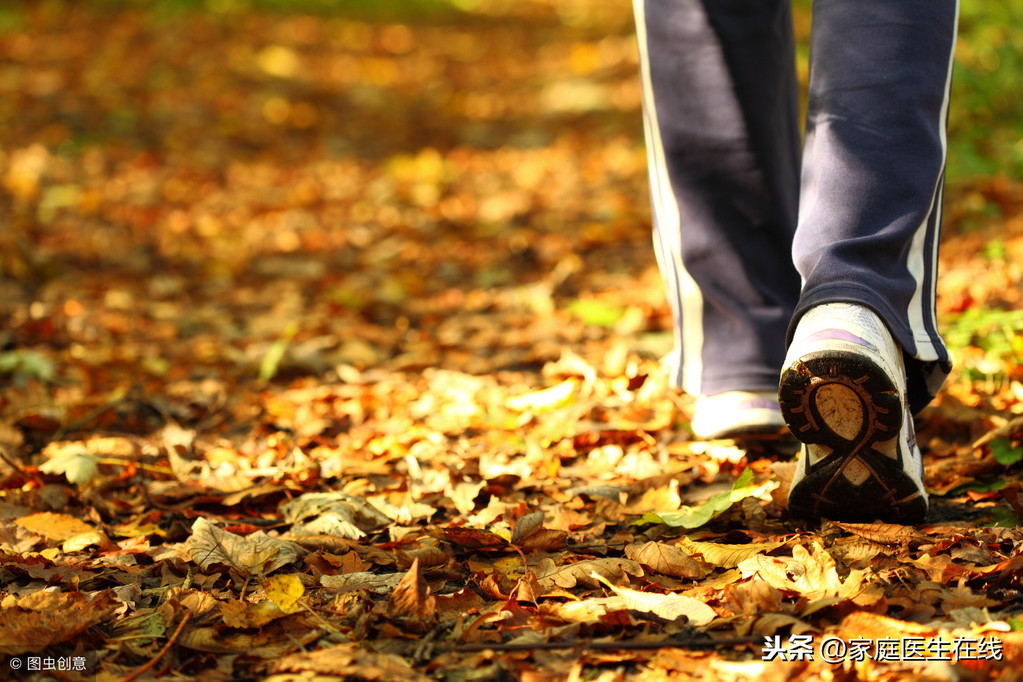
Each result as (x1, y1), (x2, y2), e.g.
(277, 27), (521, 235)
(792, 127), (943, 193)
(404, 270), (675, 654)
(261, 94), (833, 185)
(184, 516), (299, 577)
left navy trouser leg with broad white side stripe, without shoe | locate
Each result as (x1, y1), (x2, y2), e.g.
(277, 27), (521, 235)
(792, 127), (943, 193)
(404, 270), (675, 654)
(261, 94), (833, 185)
(635, 0), (800, 411)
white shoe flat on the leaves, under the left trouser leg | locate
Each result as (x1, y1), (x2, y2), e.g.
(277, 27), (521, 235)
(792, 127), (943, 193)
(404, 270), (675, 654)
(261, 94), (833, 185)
(691, 391), (785, 441)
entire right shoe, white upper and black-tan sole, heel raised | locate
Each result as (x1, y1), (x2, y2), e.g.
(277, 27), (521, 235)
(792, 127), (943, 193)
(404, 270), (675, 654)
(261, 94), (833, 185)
(779, 303), (927, 522)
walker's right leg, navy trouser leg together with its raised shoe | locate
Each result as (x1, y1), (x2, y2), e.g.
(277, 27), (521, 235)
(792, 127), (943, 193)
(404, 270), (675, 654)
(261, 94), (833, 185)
(780, 0), (958, 521)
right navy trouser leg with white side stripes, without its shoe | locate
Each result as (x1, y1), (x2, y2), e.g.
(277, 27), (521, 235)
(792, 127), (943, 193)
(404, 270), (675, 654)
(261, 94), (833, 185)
(789, 0), (959, 412)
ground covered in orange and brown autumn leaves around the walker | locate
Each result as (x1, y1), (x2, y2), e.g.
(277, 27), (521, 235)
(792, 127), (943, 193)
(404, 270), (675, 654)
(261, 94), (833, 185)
(0, 0), (1023, 681)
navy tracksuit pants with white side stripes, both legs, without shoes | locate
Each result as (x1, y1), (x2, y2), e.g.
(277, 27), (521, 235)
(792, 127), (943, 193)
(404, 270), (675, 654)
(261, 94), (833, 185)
(634, 0), (959, 411)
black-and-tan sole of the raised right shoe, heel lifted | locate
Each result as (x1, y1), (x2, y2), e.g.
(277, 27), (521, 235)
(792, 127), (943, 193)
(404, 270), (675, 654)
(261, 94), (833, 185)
(779, 351), (927, 522)
